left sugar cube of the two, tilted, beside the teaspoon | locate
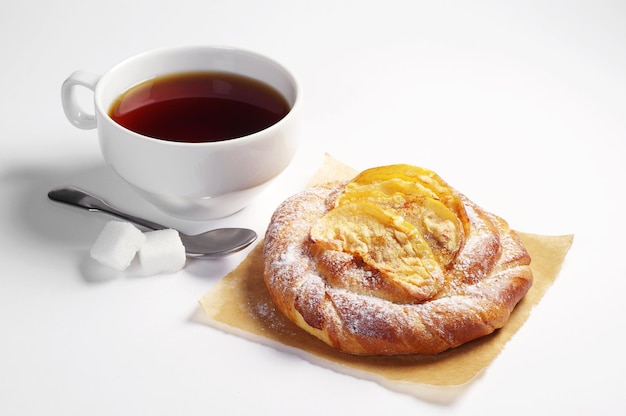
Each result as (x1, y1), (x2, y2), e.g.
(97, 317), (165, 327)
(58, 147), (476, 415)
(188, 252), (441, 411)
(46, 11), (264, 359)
(90, 221), (146, 270)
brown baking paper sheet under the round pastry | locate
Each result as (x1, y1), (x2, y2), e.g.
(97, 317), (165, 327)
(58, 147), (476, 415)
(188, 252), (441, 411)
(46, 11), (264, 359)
(200, 156), (573, 403)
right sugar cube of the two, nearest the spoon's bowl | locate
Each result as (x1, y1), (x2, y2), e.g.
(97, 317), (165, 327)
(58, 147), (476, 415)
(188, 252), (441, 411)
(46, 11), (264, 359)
(138, 229), (187, 276)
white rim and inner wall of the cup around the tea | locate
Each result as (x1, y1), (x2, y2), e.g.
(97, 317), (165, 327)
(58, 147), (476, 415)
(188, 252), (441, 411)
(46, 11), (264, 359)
(94, 45), (301, 147)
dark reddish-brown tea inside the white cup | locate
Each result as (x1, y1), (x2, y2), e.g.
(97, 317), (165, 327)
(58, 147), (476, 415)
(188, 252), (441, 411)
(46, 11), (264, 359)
(109, 72), (290, 143)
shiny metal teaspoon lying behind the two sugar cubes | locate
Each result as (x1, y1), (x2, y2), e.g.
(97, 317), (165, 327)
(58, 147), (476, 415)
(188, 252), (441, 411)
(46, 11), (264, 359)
(48, 186), (257, 259)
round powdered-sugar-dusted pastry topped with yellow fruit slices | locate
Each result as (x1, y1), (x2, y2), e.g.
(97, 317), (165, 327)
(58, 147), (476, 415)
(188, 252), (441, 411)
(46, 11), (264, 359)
(263, 165), (533, 355)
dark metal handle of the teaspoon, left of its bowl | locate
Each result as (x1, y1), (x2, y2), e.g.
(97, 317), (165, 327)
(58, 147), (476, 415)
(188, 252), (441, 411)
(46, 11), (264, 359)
(48, 186), (167, 230)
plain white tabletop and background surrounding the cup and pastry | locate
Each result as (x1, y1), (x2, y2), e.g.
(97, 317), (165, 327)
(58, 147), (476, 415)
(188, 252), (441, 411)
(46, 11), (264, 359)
(0, 0), (626, 415)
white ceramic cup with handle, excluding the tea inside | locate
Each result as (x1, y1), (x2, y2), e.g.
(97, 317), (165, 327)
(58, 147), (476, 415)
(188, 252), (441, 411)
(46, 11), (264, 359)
(61, 46), (299, 220)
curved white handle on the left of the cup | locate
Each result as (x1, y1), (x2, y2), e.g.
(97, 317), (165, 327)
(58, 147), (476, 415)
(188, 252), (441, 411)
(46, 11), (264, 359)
(61, 70), (100, 130)
